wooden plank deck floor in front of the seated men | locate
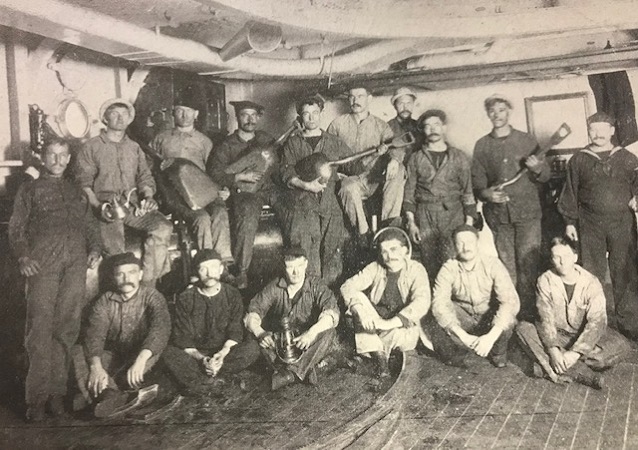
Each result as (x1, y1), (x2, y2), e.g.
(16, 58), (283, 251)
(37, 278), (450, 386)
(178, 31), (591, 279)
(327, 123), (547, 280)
(0, 346), (638, 449)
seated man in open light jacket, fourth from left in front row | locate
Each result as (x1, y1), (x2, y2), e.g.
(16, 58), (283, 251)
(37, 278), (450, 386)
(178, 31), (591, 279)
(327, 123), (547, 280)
(341, 227), (430, 378)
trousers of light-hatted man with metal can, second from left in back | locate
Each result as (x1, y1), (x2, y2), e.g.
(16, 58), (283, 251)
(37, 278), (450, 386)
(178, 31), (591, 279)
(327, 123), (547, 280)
(100, 211), (173, 285)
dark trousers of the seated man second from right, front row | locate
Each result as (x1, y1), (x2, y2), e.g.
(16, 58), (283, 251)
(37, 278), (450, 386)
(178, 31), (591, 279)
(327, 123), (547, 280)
(424, 305), (512, 364)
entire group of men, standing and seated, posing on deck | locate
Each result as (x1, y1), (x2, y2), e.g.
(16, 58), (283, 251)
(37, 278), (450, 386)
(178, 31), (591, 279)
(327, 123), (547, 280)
(9, 83), (638, 420)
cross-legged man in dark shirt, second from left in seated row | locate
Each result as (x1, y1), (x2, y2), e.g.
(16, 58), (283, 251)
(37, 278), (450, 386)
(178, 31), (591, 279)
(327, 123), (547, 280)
(162, 249), (259, 395)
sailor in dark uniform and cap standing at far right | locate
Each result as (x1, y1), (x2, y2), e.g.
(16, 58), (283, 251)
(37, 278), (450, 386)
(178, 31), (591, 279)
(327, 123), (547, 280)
(558, 112), (638, 337)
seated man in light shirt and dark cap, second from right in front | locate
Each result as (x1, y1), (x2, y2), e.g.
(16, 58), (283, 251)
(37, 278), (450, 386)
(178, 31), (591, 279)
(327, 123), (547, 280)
(426, 225), (520, 368)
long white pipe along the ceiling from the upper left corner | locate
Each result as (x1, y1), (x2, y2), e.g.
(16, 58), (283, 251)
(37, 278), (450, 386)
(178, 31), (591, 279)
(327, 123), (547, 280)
(0, 0), (418, 78)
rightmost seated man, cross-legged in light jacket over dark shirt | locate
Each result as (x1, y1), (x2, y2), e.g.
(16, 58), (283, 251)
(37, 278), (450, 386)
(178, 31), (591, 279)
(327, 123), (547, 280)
(516, 238), (631, 389)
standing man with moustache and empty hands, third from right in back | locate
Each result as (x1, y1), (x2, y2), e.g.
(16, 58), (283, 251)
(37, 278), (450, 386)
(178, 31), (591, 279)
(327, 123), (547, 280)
(403, 109), (476, 283)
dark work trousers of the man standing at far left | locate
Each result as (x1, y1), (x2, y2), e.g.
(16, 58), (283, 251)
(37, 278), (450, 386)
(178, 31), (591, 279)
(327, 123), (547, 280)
(25, 246), (87, 405)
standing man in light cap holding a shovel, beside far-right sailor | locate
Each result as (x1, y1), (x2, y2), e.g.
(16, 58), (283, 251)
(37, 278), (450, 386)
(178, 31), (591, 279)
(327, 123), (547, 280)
(472, 94), (550, 316)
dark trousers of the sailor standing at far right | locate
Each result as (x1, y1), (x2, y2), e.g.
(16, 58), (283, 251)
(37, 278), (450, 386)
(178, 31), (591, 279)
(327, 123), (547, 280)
(579, 209), (638, 336)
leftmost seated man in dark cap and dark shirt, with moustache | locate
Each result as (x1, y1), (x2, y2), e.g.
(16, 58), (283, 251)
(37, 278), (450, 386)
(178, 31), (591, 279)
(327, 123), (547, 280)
(73, 253), (171, 417)
